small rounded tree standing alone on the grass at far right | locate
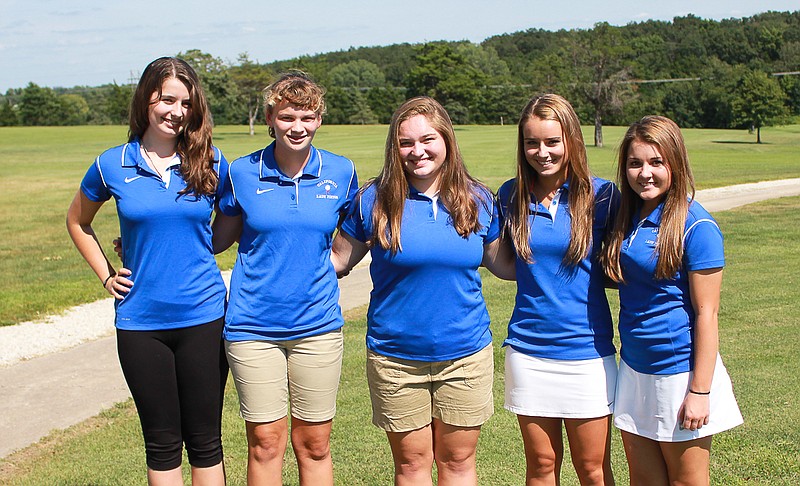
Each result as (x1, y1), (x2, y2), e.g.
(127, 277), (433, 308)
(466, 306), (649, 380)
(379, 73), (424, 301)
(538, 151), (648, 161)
(732, 71), (788, 143)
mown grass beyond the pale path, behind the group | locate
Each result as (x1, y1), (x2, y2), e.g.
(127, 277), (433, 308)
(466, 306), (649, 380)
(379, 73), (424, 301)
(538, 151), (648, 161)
(0, 125), (800, 325)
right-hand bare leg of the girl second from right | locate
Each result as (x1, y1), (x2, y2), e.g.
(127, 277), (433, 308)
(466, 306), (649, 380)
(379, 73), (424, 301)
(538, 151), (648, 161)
(564, 415), (614, 486)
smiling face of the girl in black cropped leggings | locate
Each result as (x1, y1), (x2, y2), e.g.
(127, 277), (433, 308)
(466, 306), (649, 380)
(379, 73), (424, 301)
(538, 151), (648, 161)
(147, 78), (192, 138)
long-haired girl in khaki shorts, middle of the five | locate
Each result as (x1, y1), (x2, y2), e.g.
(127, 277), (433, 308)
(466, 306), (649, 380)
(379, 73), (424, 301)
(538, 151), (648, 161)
(333, 97), (513, 485)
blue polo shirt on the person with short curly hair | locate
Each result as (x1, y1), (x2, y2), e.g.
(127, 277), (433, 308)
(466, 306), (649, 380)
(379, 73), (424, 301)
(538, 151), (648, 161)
(219, 142), (358, 341)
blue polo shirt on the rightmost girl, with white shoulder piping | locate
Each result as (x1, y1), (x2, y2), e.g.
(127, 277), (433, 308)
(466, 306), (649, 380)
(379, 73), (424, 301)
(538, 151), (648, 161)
(619, 202), (725, 375)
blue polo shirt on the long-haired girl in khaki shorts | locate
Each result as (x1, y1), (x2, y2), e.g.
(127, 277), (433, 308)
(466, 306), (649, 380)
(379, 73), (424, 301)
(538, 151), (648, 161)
(342, 185), (500, 362)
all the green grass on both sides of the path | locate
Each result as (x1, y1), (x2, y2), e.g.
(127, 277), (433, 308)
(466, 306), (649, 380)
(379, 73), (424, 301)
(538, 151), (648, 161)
(0, 126), (800, 485)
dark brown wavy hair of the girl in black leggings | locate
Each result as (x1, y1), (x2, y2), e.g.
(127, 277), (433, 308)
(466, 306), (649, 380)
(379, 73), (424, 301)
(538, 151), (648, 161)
(128, 57), (219, 196)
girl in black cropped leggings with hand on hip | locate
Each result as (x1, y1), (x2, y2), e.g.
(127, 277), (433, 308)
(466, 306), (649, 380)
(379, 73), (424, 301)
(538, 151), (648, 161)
(67, 57), (228, 485)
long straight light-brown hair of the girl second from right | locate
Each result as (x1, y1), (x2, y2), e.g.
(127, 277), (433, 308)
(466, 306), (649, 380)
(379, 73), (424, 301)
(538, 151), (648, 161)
(506, 94), (594, 265)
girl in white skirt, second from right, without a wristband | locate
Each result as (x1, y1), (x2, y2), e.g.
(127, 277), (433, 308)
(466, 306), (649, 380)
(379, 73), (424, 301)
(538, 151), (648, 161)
(498, 94), (617, 485)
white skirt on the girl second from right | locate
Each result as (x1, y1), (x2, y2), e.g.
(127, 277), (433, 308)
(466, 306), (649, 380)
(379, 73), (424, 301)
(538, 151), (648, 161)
(505, 346), (617, 418)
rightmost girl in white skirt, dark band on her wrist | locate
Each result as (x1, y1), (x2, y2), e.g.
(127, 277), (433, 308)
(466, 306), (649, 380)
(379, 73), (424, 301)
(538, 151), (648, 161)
(603, 116), (742, 485)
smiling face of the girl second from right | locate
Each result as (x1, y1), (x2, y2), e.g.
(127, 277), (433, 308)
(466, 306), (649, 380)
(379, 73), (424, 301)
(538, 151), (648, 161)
(522, 116), (569, 184)
